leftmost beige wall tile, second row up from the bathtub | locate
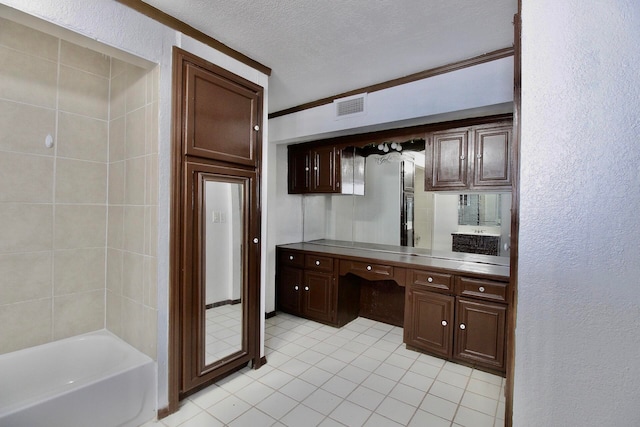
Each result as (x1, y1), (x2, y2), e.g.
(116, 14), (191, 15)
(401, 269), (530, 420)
(0, 251), (52, 304)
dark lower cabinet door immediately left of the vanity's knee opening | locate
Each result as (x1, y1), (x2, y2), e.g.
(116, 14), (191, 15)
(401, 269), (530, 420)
(302, 271), (333, 322)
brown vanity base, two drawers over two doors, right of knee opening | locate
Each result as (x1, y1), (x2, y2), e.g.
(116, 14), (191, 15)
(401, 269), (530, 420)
(404, 270), (508, 373)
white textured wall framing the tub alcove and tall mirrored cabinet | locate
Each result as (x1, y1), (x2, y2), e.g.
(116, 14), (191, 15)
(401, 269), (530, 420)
(2, 0), (273, 408)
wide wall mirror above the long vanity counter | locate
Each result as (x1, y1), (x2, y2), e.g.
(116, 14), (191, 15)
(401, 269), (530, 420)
(303, 150), (511, 263)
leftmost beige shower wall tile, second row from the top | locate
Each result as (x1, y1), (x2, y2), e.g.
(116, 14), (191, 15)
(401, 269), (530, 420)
(0, 47), (58, 108)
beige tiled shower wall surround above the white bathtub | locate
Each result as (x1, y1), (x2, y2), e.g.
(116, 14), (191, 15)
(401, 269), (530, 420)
(0, 18), (157, 358)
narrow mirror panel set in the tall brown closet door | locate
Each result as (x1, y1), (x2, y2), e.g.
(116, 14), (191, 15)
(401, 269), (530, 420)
(202, 180), (244, 365)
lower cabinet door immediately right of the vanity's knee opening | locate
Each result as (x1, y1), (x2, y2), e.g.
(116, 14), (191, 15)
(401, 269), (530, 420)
(404, 288), (455, 358)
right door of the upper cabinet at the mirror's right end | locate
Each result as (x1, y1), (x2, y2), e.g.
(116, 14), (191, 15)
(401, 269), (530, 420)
(472, 124), (513, 188)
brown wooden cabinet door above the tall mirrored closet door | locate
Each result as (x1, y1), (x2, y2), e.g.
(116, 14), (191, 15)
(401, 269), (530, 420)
(182, 56), (262, 166)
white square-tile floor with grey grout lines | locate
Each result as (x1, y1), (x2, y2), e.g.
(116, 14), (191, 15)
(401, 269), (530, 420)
(145, 313), (504, 427)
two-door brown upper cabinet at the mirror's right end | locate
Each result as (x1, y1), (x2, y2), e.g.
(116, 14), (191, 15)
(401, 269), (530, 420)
(425, 122), (513, 191)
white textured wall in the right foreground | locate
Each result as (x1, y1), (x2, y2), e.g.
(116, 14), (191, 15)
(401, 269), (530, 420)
(513, 0), (640, 426)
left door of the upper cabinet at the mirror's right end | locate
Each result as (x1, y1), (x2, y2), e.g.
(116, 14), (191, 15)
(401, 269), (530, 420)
(425, 129), (469, 191)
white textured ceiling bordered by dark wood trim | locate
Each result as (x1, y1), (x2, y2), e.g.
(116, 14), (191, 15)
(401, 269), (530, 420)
(144, 0), (517, 113)
